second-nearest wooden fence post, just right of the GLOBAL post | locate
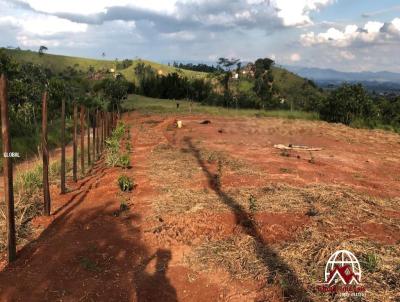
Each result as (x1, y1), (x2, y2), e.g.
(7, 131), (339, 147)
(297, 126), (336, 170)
(42, 90), (50, 216)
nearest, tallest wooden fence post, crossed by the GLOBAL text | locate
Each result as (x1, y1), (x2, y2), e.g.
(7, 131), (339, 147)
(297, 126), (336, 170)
(0, 74), (17, 262)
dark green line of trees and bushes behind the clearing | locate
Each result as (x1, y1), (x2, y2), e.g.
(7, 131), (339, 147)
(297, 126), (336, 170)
(135, 58), (400, 130)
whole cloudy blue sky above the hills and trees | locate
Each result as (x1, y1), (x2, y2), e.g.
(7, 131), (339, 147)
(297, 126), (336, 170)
(0, 0), (400, 72)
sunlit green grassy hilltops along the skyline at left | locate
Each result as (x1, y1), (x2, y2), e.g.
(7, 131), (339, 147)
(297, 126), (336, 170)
(3, 49), (207, 81)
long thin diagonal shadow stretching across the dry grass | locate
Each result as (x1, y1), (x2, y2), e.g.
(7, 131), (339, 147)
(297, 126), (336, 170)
(184, 137), (313, 302)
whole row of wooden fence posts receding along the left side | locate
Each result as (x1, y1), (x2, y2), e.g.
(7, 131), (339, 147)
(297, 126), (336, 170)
(0, 74), (116, 262)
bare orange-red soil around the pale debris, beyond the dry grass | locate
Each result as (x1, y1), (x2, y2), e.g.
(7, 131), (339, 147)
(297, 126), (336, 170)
(163, 116), (400, 197)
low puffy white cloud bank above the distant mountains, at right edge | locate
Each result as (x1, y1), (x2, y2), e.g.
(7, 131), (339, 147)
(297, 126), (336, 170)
(300, 18), (400, 47)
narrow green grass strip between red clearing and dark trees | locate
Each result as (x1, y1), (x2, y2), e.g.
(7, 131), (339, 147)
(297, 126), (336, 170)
(123, 95), (319, 120)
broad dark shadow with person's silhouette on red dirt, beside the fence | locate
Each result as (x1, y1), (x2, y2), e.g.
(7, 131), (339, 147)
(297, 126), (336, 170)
(0, 165), (176, 302)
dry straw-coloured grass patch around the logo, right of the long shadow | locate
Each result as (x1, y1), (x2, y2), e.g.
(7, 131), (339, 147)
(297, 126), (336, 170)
(279, 226), (400, 302)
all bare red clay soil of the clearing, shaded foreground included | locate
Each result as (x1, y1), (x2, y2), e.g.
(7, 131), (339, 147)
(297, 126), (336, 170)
(0, 114), (400, 302)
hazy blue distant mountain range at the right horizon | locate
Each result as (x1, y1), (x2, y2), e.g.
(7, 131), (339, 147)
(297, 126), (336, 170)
(285, 66), (400, 84)
